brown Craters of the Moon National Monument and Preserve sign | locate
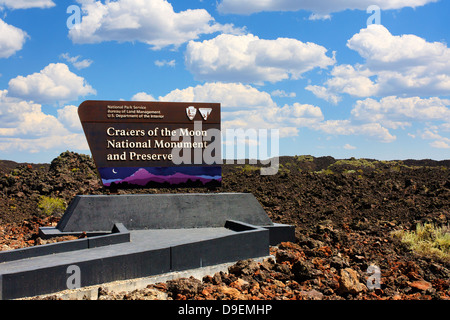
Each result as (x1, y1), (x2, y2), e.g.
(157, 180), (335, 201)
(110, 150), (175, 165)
(78, 100), (222, 188)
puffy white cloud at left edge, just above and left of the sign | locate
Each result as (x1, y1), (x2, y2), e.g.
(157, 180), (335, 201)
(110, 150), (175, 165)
(8, 63), (96, 104)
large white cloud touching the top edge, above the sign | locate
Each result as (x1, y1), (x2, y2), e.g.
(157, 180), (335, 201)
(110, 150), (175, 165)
(69, 0), (240, 49)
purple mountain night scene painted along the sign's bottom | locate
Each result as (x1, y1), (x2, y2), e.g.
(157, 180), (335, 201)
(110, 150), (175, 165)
(99, 167), (222, 188)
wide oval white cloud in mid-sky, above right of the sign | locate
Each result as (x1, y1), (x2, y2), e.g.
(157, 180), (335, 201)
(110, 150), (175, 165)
(185, 34), (335, 83)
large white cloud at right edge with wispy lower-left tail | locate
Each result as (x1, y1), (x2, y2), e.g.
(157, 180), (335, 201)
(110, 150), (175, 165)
(306, 24), (450, 101)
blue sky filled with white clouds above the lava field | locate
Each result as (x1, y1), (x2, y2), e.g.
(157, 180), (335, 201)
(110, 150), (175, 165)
(0, 0), (450, 163)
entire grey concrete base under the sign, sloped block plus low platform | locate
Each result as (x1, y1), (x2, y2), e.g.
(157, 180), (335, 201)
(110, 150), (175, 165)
(0, 194), (295, 299)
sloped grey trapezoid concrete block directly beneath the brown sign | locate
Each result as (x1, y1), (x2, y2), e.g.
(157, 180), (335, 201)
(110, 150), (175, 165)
(56, 193), (273, 232)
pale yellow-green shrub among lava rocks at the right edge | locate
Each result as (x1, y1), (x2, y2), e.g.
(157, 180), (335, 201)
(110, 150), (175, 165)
(393, 223), (450, 262)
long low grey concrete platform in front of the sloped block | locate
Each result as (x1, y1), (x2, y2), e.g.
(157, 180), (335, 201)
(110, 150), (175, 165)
(0, 221), (269, 299)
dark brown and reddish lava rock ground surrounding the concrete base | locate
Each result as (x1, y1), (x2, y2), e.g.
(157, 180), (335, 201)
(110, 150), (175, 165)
(0, 152), (450, 300)
